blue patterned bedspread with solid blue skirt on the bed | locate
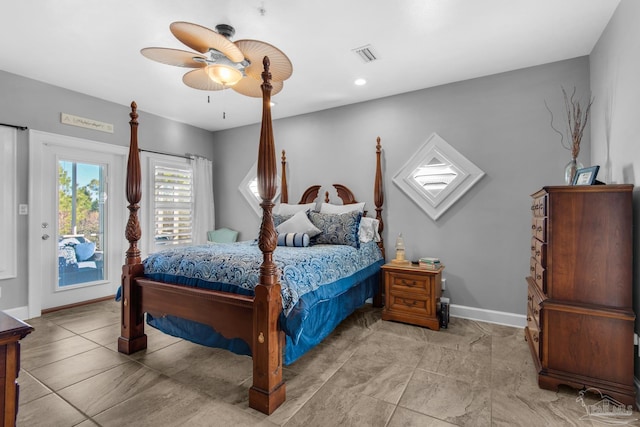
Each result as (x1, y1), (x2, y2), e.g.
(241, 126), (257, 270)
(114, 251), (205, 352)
(143, 241), (384, 364)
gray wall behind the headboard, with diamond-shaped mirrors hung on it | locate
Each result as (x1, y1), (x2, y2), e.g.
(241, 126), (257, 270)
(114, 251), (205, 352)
(214, 57), (590, 315)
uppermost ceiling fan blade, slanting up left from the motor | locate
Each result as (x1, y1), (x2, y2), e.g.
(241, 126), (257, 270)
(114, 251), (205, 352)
(169, 21), (244, 62)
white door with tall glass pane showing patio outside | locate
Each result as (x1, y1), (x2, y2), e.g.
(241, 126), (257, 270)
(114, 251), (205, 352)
(28, 130), (127, 317)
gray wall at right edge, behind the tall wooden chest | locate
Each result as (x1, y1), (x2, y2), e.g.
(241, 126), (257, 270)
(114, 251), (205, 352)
(590, 0), (640, 377)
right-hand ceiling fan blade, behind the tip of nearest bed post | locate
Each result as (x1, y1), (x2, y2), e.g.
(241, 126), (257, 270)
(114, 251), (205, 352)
(236, 40), (293, 82)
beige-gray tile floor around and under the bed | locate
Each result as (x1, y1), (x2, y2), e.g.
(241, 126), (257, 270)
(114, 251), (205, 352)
(18, 301), (640, 427)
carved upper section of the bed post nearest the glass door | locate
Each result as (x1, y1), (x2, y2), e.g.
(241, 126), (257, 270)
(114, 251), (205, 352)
(125, 101), (142, 265)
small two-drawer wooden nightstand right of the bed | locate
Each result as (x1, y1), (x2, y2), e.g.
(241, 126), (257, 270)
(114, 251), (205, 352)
(382, 263), (444, 331)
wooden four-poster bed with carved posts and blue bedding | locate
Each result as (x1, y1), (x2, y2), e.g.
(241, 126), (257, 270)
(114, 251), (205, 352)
(118, 57), (384, 414)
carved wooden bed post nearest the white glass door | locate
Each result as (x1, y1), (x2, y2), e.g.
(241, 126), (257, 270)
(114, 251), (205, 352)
(118, 102), (147, 354)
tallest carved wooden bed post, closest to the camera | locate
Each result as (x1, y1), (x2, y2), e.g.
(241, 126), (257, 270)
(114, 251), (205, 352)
(249, 56), (285, 414)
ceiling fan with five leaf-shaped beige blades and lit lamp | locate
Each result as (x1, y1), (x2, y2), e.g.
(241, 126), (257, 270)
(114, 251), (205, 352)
(140, 22), (293, 98)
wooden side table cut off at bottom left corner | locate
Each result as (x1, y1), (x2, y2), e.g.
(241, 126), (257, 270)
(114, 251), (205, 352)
(0, 311), (33, 427)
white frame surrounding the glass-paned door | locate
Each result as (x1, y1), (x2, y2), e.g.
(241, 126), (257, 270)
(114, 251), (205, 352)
(28, 130), (129, 318)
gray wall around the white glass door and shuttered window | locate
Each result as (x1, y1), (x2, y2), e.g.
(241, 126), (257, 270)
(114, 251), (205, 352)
(0, 70), (213, 310)
